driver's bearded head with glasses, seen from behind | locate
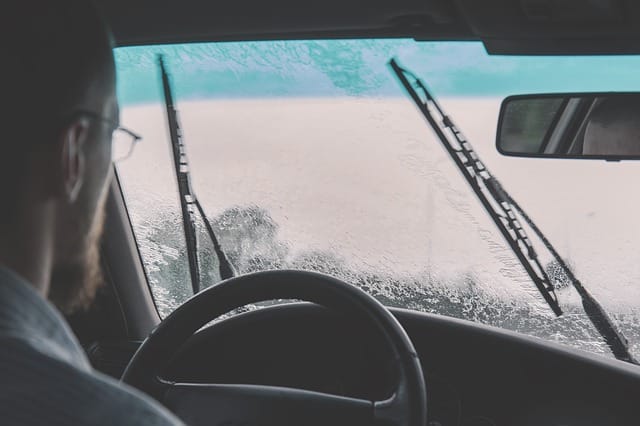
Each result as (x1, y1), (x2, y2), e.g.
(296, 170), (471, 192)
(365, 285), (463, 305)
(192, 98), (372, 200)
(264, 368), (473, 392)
(0, 0), (118, 312)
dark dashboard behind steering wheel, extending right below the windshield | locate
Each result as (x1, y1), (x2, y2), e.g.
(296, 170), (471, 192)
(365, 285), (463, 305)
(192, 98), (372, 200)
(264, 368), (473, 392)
(162, 303), (640, 426)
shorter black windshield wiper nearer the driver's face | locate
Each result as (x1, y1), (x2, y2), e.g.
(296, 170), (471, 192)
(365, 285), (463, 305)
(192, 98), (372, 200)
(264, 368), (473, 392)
(158, 55), (236, 294)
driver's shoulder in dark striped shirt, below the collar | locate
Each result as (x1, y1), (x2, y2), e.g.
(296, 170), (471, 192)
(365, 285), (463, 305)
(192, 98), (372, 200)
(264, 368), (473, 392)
(0, 339), (180, 425)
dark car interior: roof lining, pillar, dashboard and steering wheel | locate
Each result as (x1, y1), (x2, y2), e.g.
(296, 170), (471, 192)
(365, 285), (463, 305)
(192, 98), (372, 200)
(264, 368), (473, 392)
(61, 0), (640, 426)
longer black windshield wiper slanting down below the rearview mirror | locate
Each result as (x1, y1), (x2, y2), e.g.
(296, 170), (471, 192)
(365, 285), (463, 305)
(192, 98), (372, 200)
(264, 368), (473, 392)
(389, 59), (638, 364)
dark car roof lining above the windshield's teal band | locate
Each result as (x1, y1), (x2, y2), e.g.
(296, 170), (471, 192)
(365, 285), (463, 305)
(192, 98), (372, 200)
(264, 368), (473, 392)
(97, 0), (640, 54)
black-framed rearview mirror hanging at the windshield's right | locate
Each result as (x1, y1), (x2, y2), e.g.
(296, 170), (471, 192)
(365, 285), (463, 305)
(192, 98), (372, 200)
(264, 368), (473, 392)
(496, 93), (640, 160)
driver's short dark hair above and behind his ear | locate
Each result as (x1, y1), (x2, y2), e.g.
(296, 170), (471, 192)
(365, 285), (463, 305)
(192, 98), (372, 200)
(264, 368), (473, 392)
(0, 0), (113, 205)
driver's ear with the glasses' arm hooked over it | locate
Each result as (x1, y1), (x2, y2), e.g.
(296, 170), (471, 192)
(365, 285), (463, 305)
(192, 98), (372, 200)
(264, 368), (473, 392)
(60, 119), (89, 203)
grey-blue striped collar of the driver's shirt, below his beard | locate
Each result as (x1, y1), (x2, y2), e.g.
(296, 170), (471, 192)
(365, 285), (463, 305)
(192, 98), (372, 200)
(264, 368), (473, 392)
(0, 266), (90, 370)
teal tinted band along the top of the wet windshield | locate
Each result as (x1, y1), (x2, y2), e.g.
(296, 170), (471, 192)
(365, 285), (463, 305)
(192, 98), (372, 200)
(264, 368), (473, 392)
(115, 39), (640, 106)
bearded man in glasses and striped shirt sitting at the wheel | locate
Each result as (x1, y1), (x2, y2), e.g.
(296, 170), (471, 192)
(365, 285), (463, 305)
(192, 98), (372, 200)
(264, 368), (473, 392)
(0, 0), (179, 425)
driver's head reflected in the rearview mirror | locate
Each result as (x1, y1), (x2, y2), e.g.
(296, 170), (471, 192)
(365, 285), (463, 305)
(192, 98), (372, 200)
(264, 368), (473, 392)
(582, 95), (640, 155)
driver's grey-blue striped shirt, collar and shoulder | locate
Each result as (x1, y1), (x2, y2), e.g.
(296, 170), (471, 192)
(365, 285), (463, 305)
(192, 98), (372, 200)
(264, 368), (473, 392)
(0, 267), (181, 426)
